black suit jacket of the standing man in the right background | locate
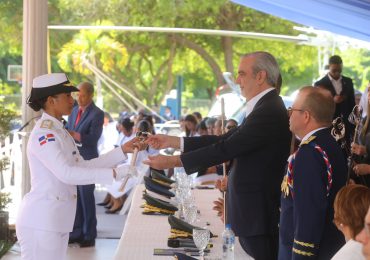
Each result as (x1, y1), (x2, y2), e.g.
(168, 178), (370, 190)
(315, 75), (355, 125)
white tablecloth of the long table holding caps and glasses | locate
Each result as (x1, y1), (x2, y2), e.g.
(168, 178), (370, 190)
(115, 184), (253, 260)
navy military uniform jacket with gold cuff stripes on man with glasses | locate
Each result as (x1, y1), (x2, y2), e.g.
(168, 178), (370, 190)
(279, 129), (347, 260)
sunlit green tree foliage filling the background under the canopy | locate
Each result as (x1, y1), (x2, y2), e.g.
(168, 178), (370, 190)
(0, 0), (370, 114)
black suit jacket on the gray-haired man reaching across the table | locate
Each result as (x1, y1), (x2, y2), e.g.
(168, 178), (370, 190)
(181, 90), (291, 237)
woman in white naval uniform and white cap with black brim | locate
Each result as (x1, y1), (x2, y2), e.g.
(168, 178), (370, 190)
(16, 73), (143, 260)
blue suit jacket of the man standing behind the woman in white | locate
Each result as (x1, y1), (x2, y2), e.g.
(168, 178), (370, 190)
(66, 102), (104, 160)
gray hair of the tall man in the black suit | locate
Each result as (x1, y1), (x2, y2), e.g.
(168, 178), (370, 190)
(242, 51), (280, 88)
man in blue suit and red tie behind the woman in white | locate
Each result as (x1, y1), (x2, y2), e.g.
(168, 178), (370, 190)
(67, 82), (104, 247)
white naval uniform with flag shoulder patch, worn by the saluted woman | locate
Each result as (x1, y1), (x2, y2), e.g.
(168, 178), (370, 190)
(16, 112), (127, 260)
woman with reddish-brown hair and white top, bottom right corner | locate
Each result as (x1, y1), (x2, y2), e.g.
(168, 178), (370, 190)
(332, 184), (370, 260)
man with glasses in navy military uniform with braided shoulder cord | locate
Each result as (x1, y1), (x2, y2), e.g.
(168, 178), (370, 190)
(279, 87), (347, 260)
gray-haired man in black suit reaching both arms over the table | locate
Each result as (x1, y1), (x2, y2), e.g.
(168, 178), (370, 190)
(146, 52), (291, 260)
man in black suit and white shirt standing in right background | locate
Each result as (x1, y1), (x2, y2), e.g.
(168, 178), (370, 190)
(315, 55), (355, 145)
